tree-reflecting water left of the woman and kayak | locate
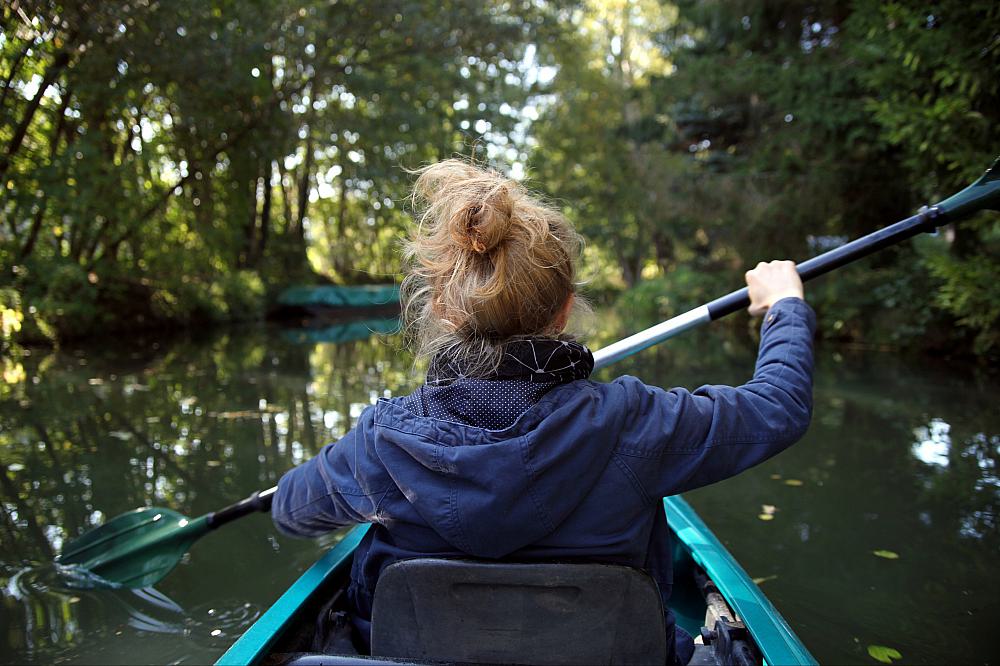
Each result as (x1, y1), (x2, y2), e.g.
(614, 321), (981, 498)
(0, 320), (411, 662)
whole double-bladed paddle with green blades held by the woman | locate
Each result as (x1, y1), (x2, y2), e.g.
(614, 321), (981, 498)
(57, 158), (1000, 587)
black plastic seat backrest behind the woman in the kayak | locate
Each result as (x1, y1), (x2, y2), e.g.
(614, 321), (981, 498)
(371, 558), (667, 665)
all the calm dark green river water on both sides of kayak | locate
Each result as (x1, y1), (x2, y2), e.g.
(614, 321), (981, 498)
(0, 314), (1000, 664)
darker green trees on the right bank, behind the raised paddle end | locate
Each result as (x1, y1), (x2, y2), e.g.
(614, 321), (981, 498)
(533, 0), (1000, 353)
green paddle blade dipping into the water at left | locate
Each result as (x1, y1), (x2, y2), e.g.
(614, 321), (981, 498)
(56, 507), (209, 587)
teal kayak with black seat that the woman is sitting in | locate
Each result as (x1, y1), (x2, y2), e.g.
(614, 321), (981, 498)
(216, 496), (817, 666)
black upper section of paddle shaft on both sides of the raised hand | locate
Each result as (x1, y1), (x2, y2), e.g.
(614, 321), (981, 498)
(707, 207), (947, 321)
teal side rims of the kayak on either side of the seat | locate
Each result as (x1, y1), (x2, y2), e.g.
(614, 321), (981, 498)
(216, 496), (816, 666)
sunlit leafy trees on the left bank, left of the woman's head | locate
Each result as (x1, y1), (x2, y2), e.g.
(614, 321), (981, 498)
(0, 0), (549, 337)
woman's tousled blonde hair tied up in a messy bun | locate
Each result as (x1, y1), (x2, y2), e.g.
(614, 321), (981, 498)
(401, 159), (586, 372)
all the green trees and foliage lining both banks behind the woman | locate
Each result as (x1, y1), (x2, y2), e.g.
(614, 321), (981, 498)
(0, 0), (1000, 365)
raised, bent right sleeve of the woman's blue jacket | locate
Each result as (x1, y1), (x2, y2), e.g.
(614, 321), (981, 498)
(616, 298), (816, 498)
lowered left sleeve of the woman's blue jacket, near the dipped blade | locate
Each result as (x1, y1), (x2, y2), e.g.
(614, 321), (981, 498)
(271, 408), (385, 537)
